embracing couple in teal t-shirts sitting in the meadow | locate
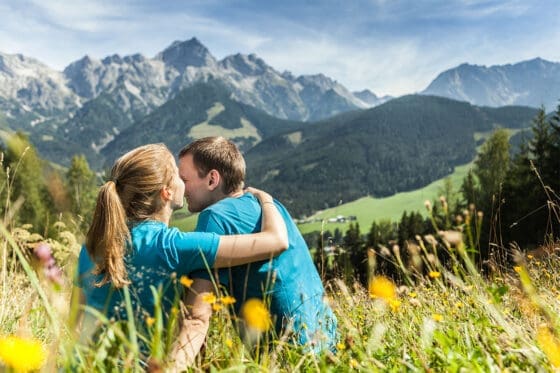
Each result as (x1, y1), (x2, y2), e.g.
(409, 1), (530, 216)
(77, 137), (336, 368)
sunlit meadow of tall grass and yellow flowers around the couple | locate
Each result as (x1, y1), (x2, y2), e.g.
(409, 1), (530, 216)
(0, 150), (560, 372)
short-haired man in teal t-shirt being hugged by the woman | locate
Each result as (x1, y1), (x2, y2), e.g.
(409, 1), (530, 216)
(179, 137), (336, 351)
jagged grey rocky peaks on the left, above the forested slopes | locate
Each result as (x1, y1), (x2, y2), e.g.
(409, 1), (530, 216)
(0, 38), (384, 128)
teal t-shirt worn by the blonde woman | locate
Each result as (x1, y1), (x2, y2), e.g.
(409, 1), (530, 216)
(78, 220), (220, 319)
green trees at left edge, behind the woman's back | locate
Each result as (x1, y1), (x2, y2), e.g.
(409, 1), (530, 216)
(0, 133), (101, 237)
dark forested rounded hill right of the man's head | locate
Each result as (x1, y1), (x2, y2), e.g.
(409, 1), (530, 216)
(246, 95), (536, 217)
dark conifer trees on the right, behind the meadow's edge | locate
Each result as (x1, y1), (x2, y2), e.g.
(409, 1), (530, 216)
(306, 100), (560, 284)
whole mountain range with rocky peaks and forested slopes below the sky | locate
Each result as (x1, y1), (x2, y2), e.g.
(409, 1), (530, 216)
(0, 38), (560, 216)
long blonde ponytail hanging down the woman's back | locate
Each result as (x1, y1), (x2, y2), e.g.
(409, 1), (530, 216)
(86, 180), (130, 288)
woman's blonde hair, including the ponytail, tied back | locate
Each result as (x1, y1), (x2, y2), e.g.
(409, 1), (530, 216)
(86, 144), (176, 288)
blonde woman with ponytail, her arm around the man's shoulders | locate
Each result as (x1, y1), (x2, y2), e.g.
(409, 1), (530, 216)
(72, 144), (288, 360)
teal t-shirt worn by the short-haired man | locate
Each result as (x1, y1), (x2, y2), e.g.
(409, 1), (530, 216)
(193, 193), (336, 351)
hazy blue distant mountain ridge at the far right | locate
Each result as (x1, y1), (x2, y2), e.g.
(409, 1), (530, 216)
(422, 58), (560, 111)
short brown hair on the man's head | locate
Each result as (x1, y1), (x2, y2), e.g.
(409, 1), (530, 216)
(179, 136), (245, 194)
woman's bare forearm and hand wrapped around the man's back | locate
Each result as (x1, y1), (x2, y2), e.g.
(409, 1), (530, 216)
(214, 188), (288, 268)
